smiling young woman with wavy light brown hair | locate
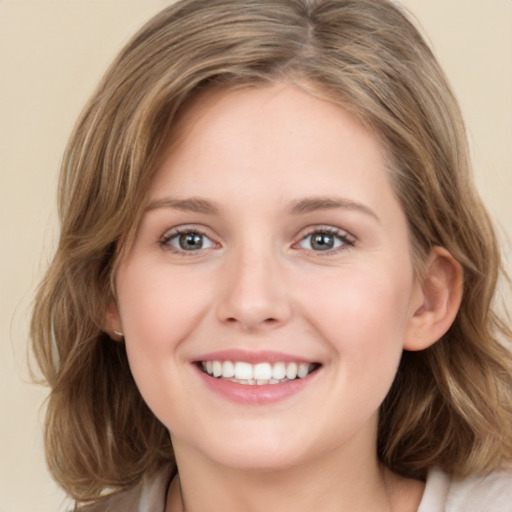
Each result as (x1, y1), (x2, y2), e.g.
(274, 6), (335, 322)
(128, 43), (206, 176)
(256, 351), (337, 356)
(33, 0), (512, 512)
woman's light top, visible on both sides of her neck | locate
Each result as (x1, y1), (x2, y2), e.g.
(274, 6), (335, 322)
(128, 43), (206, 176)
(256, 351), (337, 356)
(85, 468), (512, 512)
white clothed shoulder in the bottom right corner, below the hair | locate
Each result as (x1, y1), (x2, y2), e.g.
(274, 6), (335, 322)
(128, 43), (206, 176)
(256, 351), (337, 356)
(418, 468), (512, 512)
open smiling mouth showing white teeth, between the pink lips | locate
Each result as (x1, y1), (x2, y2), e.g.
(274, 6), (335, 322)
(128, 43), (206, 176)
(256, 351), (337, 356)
(198, 360), (321, 386)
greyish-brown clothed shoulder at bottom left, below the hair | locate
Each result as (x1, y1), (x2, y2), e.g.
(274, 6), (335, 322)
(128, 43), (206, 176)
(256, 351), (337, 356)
(79, 468), (172, 512)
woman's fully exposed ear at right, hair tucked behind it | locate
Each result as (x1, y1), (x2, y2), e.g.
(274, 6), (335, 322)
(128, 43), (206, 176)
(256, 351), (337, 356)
(404, 247), (463, 350)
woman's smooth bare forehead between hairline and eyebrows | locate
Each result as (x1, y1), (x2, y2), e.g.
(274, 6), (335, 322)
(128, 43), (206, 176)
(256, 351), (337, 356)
(153, 83), (387, 194)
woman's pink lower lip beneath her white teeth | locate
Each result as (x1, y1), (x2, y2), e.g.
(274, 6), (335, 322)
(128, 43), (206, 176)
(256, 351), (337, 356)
(197, 368), (318, 405)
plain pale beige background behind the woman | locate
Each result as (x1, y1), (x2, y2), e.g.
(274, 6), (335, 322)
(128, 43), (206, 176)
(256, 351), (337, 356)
(0, 0), (512, 512)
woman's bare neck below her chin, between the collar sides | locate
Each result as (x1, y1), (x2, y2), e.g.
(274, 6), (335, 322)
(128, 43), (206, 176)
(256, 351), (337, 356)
(166, 436), (422, 512)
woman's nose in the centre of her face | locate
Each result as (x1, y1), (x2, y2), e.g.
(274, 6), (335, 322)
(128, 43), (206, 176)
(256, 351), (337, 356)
(217, 245), (292, 331)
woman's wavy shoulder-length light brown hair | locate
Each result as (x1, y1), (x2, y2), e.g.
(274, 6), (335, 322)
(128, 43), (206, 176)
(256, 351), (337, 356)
(31, 0), (512, 500)
